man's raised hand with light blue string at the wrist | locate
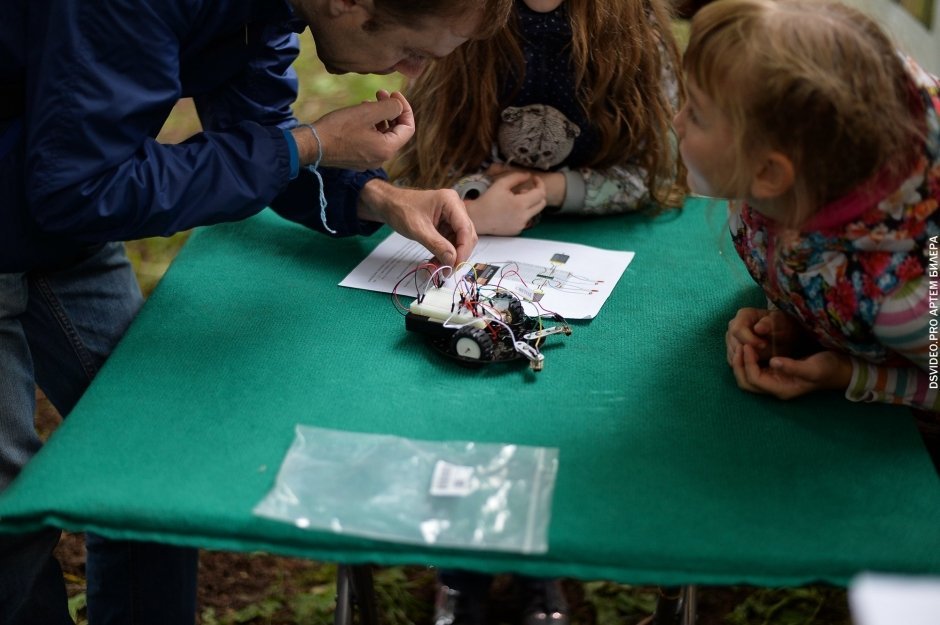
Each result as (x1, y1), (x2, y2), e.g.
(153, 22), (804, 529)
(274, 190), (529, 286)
(291, 91), (415, 170)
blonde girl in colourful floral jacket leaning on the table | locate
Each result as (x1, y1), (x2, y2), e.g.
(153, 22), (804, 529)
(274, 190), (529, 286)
(675, 0), (940, 454)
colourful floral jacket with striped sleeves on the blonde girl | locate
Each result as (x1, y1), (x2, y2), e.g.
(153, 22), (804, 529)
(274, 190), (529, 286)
(731, 57), (940, 410)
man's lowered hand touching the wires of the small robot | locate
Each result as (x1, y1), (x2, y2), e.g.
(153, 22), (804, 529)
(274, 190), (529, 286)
(359, 180), (477, 267)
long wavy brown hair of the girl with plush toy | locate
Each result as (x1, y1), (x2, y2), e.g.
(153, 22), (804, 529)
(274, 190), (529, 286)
(390, 0), (684, 210)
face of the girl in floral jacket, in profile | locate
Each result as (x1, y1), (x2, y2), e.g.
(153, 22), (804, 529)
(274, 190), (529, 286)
(673, 79), (741, 198)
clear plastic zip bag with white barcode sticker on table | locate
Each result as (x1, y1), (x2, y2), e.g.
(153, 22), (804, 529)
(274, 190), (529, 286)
(254, 425), (558, 553)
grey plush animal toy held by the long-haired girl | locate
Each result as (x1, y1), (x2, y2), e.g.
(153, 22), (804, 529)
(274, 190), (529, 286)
(497, 104), (581, 170)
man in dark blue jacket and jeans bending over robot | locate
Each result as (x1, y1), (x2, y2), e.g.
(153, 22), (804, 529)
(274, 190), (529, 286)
(0, 0), (511, 625)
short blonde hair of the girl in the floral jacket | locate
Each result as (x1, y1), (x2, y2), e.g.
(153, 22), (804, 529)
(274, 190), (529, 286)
(683, 0), (923, 226)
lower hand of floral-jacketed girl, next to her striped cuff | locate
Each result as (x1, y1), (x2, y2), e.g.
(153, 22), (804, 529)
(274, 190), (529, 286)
(731, 344), (852, 399)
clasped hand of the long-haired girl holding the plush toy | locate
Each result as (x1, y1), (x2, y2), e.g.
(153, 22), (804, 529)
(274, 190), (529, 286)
(466, 172), (545, 236)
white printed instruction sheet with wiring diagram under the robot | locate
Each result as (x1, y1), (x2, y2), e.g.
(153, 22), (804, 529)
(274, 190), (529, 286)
(339, 233), (634, 319)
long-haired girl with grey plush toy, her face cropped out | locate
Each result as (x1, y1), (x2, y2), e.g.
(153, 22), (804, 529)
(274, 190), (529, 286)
(391, 0), (684, 235)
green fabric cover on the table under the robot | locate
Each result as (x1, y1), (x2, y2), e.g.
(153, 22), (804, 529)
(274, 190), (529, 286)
(0, 200), (940, 585)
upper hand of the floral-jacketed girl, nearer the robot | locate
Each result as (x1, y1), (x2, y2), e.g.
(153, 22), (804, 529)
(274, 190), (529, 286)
(725, 308), (803, 366)
